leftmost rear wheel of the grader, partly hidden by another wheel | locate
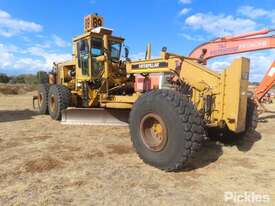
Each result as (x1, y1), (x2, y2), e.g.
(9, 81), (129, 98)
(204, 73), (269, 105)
(37, 84), (49, 114)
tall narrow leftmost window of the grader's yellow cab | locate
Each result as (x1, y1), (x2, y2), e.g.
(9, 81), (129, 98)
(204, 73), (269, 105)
(77, 40), (89, 76)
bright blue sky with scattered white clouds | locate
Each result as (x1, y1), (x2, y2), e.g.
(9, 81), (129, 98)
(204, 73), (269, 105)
(0, 0), (275, 81)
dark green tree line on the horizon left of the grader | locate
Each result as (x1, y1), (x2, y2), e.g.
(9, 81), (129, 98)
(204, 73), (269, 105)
(0, 71), (48, 85)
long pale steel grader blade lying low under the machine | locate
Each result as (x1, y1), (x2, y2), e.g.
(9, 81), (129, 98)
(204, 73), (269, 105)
(61, 108), (130, 126)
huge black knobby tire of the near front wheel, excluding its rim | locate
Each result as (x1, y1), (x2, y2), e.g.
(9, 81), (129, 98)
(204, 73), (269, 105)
(129, 90), (205, 171)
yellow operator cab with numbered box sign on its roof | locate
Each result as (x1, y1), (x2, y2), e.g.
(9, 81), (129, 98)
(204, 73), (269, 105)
(73, 14), (124, 81)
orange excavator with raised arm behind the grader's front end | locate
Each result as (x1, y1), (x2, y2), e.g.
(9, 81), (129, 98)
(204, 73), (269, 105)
(189, 29), (275, 110)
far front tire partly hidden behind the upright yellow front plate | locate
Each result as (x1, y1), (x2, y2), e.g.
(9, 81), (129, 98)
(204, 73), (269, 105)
(246, 98), (258, 132)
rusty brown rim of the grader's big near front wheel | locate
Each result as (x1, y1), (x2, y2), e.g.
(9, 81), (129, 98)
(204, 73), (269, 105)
(140, 113), (168, 152)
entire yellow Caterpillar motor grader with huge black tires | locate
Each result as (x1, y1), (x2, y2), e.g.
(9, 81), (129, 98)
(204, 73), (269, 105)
(37, 15), (257, 171)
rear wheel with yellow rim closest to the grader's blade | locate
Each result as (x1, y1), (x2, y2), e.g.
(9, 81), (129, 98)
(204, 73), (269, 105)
(48, 85), (71, 120)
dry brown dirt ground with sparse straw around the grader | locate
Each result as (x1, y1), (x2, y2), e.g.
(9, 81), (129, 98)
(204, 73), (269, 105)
(0, 93), (275, 205)
